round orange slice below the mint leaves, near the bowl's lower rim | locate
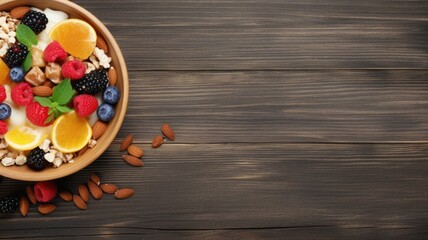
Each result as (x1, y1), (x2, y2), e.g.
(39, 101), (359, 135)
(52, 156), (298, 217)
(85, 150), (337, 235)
(51, 111), (92, 153)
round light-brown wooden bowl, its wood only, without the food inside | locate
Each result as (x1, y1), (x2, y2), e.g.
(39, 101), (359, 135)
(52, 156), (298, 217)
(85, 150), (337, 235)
(0, 0), (129, 181)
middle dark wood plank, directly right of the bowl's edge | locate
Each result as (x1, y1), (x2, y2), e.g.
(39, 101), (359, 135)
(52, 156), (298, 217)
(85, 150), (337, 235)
(121, 70), (428, 143)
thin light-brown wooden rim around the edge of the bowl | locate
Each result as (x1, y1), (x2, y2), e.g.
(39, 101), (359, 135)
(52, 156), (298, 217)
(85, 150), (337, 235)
(0, 0), (129, 181)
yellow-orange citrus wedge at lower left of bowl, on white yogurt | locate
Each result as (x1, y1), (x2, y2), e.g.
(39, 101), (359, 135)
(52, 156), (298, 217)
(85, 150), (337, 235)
(4, 126), (47, 151)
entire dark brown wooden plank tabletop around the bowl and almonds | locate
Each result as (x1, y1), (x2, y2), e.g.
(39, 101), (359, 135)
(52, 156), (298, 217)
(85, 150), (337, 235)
(0, 0), (428, 240)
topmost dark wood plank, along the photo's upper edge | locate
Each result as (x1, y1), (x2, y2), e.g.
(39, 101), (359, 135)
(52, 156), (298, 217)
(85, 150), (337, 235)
(75, 0), (428, 70)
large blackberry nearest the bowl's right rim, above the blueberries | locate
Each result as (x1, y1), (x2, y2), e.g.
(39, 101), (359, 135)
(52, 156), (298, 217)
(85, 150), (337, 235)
(71, 69), (108, 94)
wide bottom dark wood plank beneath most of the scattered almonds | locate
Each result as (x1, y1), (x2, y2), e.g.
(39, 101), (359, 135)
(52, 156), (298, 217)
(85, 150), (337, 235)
(0, 142), (428, 239)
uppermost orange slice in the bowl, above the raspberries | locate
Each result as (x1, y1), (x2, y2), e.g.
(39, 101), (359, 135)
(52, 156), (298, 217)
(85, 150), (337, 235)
(49, 19), (97, 59)
